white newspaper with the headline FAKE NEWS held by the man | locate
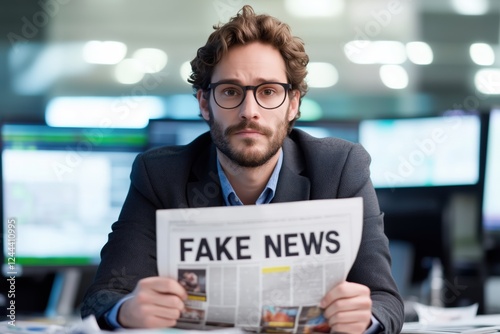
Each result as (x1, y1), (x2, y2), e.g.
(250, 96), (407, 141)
(156, 198), (363, 333)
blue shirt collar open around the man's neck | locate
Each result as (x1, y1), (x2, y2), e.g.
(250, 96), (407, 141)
(217, 150), (283, 206)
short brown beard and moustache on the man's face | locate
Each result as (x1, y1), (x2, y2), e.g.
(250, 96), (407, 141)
(208, 106), (290, 167)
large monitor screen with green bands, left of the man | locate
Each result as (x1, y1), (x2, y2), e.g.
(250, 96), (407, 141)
(1, 124), (147, 266)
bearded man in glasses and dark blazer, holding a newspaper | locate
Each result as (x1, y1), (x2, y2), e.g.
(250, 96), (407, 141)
(82, 6), (403, 333)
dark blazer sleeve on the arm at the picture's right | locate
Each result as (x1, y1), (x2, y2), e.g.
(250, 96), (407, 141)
(338, 144), (404, 333)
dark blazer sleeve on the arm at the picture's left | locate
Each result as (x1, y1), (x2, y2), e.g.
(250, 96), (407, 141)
(81, 155), (161, 329)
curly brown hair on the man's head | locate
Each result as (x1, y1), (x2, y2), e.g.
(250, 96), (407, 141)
(188, 5), (309, 116)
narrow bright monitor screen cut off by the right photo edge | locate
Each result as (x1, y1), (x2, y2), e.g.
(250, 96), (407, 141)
(483, 109), (500, 235)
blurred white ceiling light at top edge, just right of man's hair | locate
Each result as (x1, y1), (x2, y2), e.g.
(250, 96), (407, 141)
(285, 0), (345, 17)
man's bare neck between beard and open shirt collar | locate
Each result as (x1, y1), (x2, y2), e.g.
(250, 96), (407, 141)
(217, 150), (281, 205)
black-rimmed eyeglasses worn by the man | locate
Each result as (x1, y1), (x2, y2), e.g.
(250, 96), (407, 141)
(208, 82), (292, 109)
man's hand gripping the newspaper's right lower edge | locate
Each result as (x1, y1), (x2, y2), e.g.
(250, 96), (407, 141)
(320, 282), (372, 334)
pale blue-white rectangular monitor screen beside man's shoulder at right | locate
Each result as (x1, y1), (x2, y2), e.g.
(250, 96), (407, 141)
(359, 114), (481, 188)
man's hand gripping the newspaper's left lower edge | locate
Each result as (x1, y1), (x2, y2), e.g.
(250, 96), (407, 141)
(118, 277), (187, 328)
